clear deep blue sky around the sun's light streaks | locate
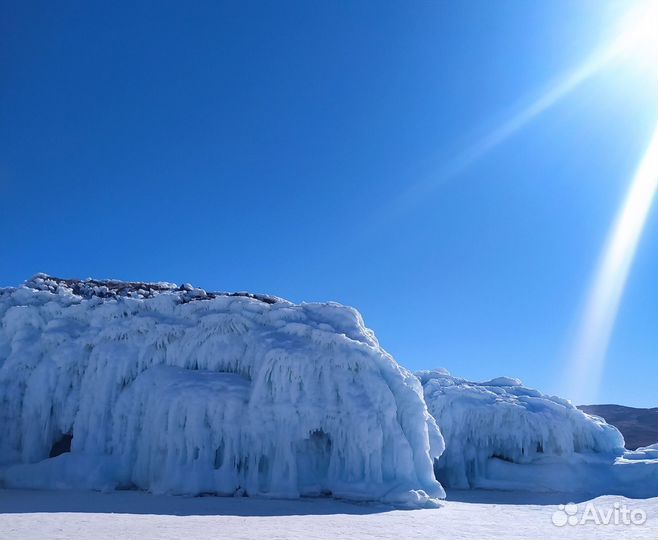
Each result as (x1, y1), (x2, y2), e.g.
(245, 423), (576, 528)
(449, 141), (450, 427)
(0, 0), (658, 406)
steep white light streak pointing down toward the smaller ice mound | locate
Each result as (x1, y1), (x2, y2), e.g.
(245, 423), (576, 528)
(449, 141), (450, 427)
(567, 126), (658, 403)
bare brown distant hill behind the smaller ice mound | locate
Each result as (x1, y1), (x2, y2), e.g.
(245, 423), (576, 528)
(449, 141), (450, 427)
(578, 405), (658, 450)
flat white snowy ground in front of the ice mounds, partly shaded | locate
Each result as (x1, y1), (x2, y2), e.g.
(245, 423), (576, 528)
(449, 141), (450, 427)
(0, 490), (658, 540)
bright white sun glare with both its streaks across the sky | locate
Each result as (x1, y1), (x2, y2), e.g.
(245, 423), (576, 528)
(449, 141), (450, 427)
(380, 0), (658, 403)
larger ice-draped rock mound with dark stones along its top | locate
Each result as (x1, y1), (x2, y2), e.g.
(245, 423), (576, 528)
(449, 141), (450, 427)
(0, 274), (444, 506)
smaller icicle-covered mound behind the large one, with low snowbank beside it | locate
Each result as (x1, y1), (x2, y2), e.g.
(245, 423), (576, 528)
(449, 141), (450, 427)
(416, 369), (658, 497)
